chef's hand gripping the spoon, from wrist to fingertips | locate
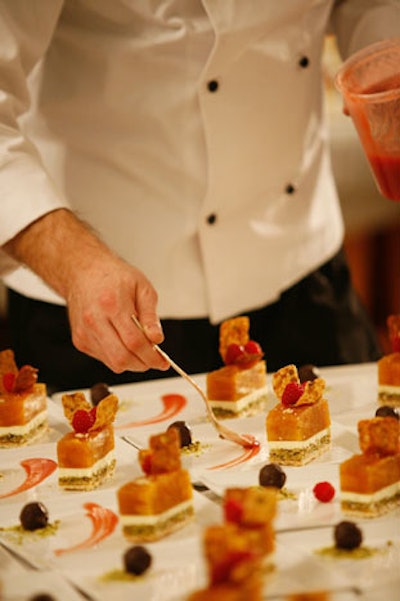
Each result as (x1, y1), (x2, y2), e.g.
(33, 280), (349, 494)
(66, 256), (169, 373)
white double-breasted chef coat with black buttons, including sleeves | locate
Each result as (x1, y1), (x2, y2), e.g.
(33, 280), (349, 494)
(0, 0), (400, 322)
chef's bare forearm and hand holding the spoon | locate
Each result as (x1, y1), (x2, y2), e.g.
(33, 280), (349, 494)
(3, 209), (169, 373)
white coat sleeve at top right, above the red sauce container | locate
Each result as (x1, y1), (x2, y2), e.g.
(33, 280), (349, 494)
(331, 0), (400, 59)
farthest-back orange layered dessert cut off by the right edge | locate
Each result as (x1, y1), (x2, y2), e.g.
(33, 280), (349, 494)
(378, 314), (400, 407)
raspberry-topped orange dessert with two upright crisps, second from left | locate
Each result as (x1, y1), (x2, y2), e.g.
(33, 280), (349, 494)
(57, 392), (118, 490)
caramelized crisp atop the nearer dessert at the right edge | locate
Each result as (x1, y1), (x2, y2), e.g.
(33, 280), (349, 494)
(358, 417), (400, 456)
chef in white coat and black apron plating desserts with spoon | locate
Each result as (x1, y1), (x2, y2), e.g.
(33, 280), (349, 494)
(0, 0), (400, 389)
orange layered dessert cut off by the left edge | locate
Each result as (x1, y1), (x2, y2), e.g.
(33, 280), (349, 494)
(0, 349), (47, 447)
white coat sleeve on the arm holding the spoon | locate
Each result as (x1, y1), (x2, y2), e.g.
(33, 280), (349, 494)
(0, 0), (67, 274)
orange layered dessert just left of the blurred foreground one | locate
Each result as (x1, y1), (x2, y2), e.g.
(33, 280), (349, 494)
(117, 428), (194, 542)
